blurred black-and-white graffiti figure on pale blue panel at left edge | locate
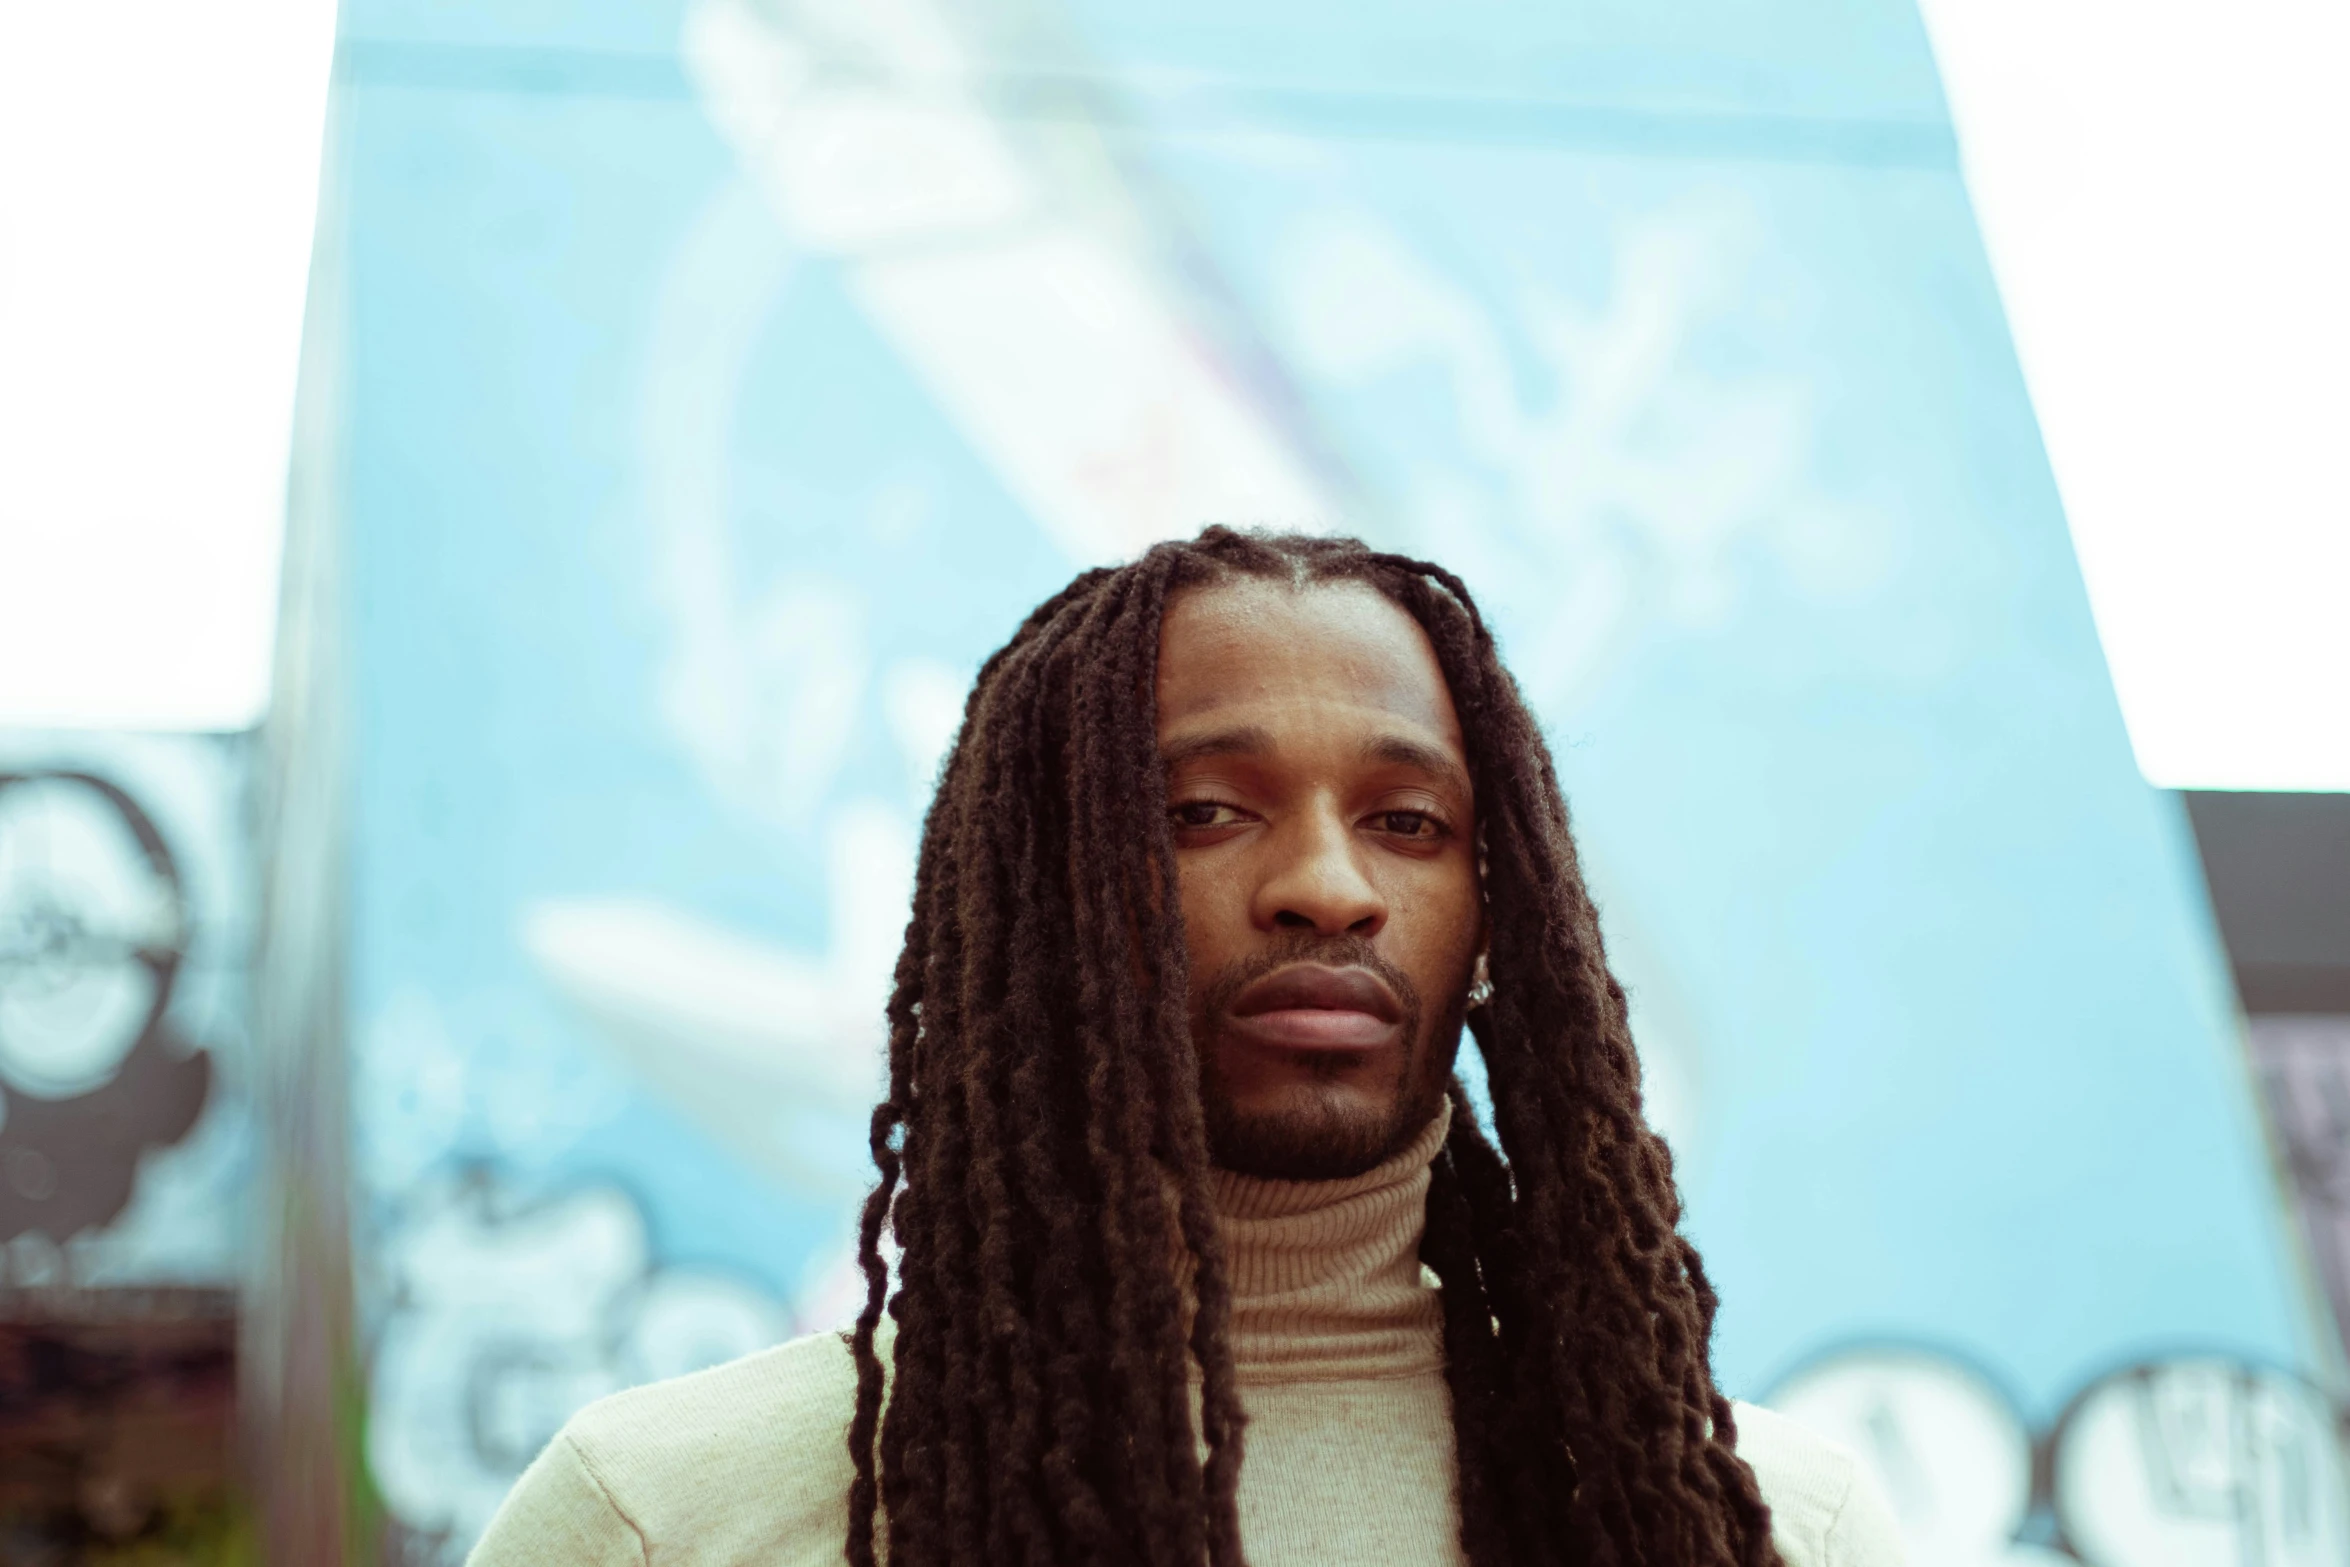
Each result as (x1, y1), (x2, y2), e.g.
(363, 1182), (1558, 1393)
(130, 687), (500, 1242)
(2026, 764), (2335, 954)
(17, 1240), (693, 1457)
(0, 735), (249, 1285)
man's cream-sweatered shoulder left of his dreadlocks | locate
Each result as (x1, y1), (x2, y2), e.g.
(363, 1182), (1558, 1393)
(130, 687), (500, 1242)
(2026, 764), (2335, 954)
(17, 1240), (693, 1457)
(472, 1332), (855, 1567)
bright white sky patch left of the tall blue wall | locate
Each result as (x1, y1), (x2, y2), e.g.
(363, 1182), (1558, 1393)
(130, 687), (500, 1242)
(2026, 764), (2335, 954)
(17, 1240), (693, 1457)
(0, 0), (334, 728)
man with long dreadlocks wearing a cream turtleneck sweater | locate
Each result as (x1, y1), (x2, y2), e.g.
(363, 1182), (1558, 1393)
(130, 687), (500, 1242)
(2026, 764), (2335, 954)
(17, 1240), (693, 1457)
(475, 529), (1899, 1567)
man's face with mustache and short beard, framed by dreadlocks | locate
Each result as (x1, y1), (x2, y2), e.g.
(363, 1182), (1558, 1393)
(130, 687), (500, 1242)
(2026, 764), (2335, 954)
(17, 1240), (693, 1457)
(1159, 578), (1483, 1179)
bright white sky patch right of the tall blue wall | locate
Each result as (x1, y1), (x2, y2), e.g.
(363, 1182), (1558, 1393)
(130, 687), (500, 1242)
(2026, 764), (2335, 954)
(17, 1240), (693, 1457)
(1922, 0), (2350, 789)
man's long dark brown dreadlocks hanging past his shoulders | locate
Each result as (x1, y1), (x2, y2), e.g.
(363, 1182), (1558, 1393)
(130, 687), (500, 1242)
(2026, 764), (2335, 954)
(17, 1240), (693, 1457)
(848, 529), (1777, 1567)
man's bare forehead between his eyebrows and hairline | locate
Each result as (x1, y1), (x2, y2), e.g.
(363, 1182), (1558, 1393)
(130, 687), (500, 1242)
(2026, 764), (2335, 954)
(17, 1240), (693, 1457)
(1159, 578), (1462, 752)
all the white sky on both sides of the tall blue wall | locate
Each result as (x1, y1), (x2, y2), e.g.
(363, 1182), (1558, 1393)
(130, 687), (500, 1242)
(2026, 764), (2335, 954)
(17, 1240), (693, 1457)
(0, 0), (2350, 789)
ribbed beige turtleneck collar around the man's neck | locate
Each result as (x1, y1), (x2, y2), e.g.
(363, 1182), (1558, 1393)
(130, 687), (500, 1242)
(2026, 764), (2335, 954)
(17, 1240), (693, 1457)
(1210, 1104), (1452, 1381)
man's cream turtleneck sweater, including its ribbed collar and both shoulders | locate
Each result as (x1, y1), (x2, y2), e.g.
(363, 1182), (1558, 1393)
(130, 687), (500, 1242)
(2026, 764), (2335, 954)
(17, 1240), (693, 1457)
(470, 1118), (1901, 1567)
